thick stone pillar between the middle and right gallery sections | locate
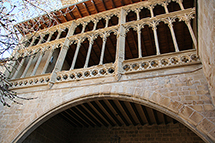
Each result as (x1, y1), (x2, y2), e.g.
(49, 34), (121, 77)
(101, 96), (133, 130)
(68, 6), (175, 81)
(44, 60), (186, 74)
(115, 8), (126, 80)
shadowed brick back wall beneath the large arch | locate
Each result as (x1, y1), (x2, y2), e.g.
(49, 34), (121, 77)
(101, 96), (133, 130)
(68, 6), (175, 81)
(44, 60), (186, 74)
(70, 123), (203, 143)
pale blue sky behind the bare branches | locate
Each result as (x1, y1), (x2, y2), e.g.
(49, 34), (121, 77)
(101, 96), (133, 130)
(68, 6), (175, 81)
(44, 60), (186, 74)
(0, 0), (62, 59)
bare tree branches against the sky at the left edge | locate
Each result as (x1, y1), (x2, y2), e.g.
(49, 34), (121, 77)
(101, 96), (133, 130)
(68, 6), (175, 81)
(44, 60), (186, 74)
(0, 0), (66, 107)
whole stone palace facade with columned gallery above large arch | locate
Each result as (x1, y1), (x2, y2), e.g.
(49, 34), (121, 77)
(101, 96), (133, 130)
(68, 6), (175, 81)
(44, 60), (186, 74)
(0, 0), (215, 143)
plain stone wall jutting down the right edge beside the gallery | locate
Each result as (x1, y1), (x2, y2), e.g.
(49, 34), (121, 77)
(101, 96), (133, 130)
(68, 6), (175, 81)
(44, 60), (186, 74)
(198, 0), (215, 105)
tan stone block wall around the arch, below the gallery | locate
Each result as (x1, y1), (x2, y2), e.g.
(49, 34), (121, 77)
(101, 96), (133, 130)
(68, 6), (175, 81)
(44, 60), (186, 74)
(0, 64), (215, 143)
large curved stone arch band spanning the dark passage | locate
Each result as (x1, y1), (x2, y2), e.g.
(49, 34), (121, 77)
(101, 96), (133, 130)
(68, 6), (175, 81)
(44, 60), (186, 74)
(12, 85), (215, 142)
